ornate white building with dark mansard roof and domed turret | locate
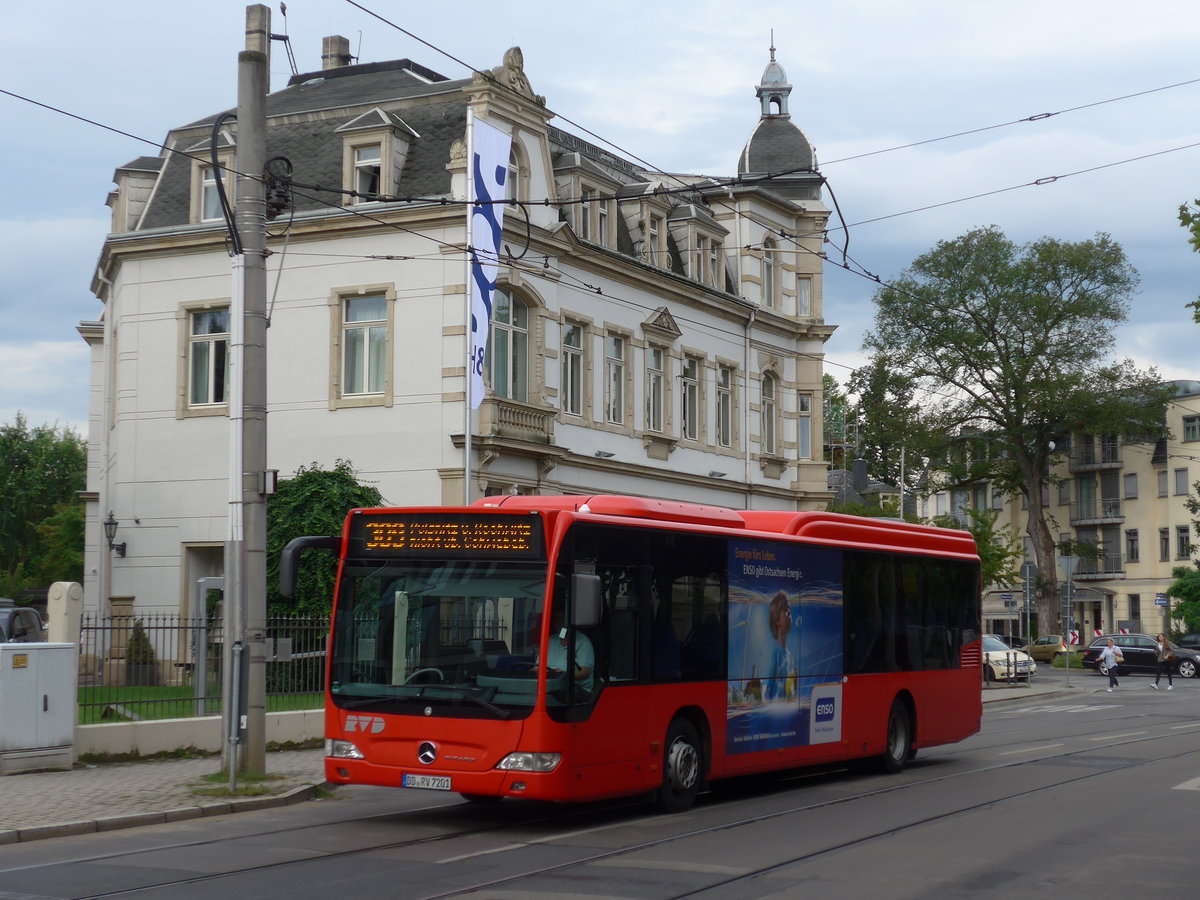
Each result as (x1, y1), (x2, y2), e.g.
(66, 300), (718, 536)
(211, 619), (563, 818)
(79, 37), (833, 613)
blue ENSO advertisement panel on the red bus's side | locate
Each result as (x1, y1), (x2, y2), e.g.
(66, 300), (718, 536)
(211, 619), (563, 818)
(726, 541), (842, 754)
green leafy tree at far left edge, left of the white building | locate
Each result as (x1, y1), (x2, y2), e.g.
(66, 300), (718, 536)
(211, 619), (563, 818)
(0, 413), (88, 587)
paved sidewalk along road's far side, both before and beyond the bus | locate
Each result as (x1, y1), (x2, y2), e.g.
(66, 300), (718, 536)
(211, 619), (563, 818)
(0, 676), (1086, 844)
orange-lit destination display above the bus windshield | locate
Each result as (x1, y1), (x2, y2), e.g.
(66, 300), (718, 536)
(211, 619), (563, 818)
(350, 514), (542, 559)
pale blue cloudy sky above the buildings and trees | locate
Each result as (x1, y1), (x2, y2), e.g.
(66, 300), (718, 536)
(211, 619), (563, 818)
(0, 0), (1200, 434)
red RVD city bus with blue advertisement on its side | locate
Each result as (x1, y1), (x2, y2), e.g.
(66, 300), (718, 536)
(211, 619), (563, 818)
(281, 496), (982, 810)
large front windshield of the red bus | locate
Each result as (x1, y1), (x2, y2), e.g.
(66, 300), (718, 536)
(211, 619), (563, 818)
(329, 559), (546, 719)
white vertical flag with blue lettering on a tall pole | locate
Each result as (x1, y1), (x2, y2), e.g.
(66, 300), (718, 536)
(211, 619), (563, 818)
(467, 119), (512, 409)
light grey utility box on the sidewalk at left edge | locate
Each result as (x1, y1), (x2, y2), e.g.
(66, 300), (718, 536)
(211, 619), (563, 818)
(0, 643), (76, 775)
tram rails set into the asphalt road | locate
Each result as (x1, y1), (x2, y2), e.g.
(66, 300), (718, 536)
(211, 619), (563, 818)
(31, 726), (1200, 900)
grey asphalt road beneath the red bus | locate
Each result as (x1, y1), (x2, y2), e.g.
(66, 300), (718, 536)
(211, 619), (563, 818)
(0, 671), (1200, 900)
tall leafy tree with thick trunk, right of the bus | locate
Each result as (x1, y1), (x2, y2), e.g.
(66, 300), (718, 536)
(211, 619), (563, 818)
(864, 227), (1170, 634)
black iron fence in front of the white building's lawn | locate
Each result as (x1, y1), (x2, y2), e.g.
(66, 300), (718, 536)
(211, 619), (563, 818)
(79, 614), (329, 725)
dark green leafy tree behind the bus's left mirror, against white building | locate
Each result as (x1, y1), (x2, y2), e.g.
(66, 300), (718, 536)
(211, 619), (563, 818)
(266, 460), (383, 616)
